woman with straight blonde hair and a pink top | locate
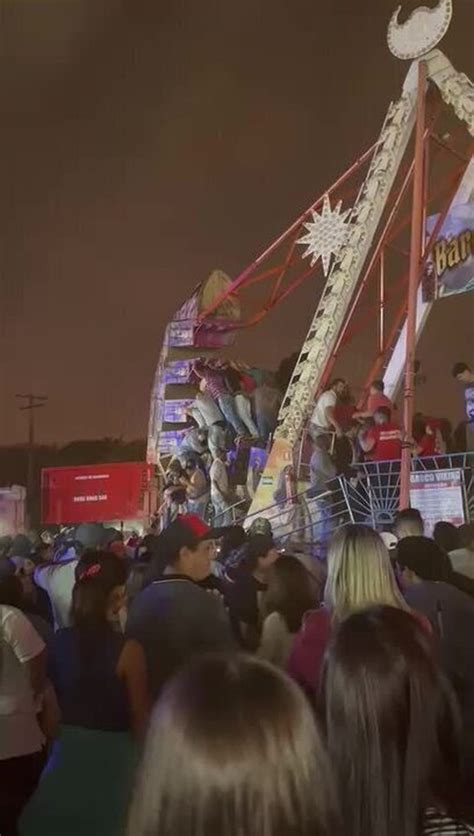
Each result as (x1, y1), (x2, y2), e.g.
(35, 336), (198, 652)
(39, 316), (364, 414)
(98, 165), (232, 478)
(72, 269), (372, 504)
(287, 525), (411, 695)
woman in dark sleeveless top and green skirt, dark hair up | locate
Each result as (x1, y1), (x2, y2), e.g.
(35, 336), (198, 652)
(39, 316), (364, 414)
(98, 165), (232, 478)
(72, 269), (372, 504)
(21, 551), (148, 836)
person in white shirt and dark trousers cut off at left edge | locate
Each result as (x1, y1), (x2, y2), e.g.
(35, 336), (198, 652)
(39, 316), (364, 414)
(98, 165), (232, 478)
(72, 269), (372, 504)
(0, 605), (46, 836)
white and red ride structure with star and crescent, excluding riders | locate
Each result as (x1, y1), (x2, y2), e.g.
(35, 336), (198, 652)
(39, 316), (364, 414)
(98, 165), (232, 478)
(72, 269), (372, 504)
(148, 0), (474, 536)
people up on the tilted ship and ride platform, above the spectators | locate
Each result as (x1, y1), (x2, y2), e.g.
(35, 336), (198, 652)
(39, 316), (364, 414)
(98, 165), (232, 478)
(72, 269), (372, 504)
(161, 360), (473, 526)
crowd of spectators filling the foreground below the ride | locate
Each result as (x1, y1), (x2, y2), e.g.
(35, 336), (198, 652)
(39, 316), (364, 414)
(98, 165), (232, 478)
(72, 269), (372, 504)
(0, 509), (474, 836)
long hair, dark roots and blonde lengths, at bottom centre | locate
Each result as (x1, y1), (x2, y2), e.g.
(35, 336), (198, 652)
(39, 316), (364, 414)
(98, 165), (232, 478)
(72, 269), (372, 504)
(127, 655), (339, 836)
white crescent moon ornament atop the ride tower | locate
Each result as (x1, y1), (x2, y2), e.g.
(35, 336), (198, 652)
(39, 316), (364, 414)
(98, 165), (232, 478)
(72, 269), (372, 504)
(387, 0), (453, 60)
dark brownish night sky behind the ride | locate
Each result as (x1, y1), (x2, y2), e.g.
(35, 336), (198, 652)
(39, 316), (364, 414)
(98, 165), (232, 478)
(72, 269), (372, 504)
(0, 0), (474, 442)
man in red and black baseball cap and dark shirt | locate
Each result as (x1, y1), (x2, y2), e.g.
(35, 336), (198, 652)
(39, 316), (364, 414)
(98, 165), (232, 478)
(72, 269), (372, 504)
(126, 514), (233, 698)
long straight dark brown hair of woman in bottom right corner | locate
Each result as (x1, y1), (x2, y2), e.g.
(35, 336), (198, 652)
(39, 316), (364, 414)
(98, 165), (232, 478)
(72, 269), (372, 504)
(323, 607), (474, 836)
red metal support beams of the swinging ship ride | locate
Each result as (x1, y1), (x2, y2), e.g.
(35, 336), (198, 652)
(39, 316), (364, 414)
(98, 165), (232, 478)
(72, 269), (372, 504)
(188, 85), (469, 484)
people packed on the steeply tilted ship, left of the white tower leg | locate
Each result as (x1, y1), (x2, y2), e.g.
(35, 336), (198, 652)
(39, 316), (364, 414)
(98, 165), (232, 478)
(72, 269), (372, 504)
(162, 359), (282, 526)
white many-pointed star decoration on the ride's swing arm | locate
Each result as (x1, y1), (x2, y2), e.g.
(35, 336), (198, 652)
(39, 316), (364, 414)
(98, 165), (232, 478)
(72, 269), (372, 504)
(297, 194), (351, 276)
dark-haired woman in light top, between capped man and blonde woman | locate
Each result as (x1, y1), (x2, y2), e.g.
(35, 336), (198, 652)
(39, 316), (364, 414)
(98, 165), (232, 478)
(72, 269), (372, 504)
(258, 555), (319, 667)
